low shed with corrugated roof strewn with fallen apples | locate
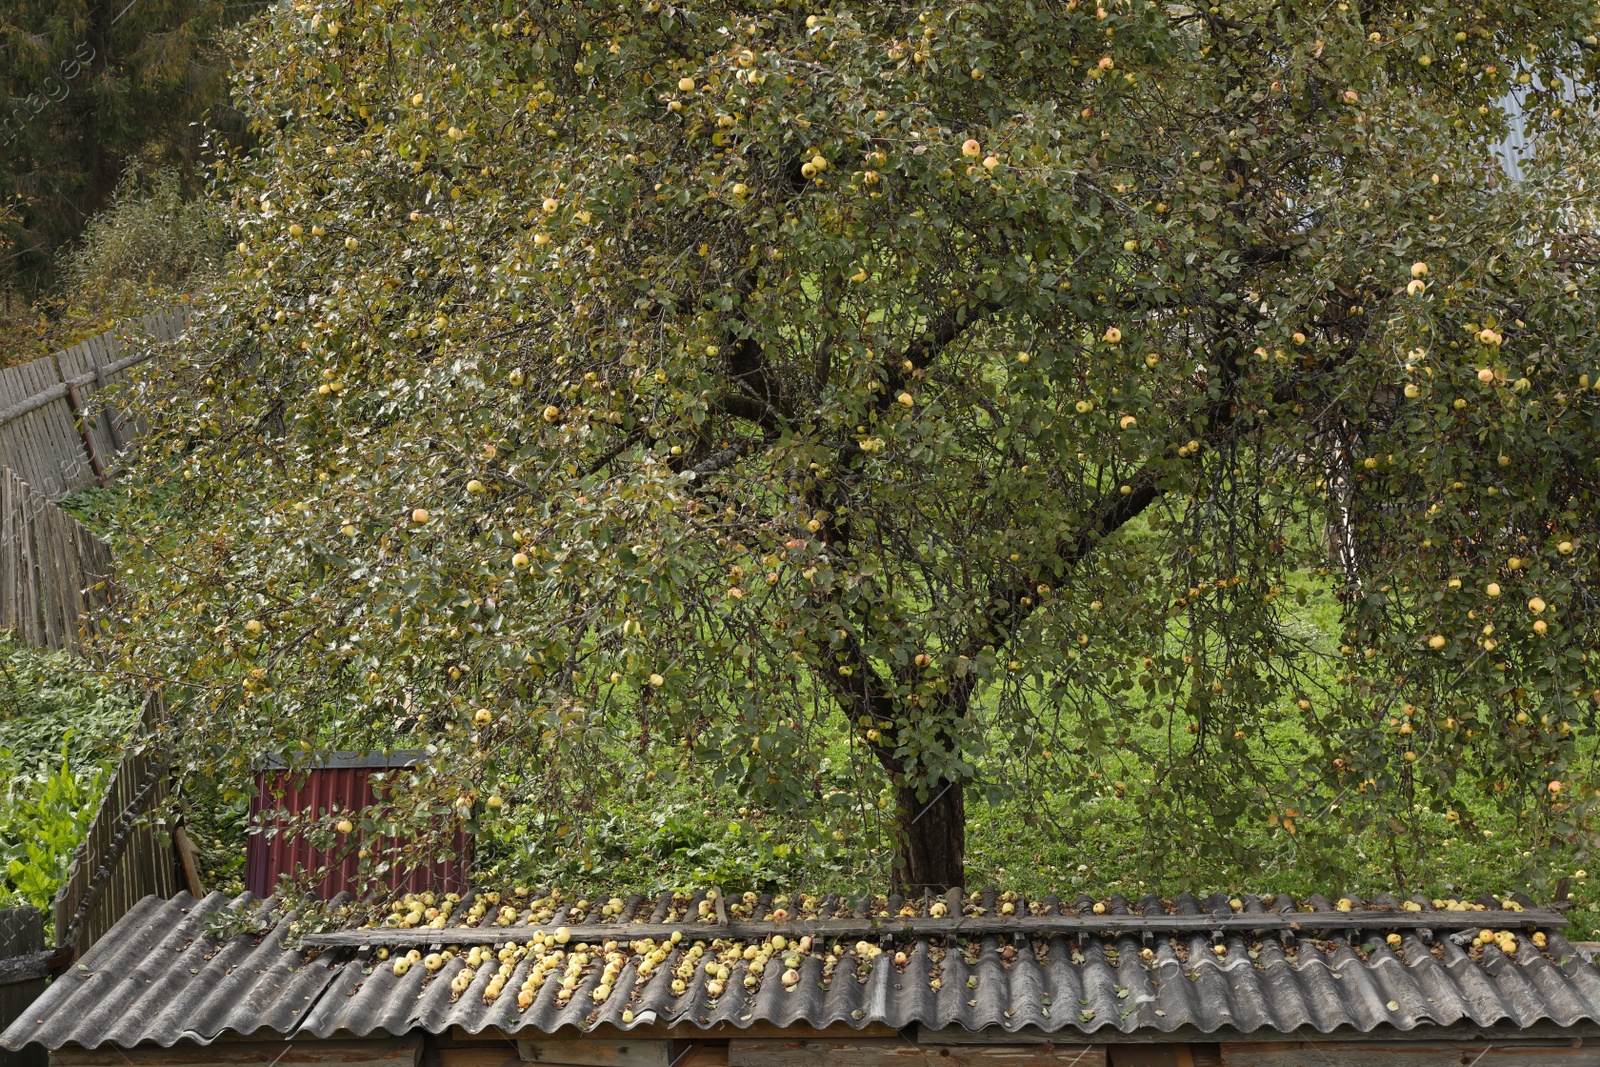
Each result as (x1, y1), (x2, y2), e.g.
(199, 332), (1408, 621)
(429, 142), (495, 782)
(0, 889), (1600, 1067)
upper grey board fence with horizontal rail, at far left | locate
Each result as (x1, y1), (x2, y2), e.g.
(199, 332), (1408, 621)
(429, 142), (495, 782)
(0, 307), (189, 501)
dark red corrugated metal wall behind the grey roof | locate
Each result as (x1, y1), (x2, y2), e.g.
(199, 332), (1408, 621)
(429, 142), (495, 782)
(245, 766), (472, 897)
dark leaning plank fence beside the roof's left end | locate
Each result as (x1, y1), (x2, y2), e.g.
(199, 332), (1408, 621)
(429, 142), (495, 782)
(54, 693), (181, 955)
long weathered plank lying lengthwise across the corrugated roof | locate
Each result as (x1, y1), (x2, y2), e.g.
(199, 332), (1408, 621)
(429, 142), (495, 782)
(304, 907), (1566, 947)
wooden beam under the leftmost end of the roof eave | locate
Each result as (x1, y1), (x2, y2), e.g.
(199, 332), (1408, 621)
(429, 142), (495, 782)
(50, 1037), (422, 1067)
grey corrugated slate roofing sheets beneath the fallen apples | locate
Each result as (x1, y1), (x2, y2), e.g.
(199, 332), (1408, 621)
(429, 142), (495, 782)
(9, 894), (1600, 1049)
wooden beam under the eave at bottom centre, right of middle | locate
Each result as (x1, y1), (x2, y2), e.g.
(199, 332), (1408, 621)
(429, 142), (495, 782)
(728, 1040), (1106, 1067)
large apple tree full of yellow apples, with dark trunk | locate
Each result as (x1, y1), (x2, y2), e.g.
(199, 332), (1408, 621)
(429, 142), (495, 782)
(117, 0), (1600, 889)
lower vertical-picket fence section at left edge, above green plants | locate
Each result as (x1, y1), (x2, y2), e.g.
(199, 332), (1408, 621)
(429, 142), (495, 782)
(0, 470), (112, 651)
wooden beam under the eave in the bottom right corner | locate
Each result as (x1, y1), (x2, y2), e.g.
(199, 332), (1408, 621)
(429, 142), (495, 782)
(1222, 1040), (1600, 1067)
